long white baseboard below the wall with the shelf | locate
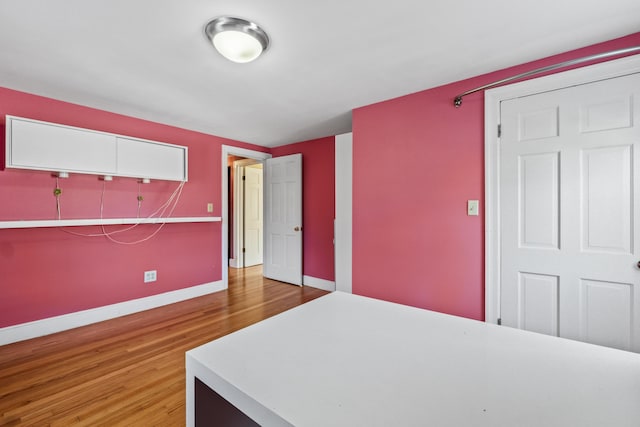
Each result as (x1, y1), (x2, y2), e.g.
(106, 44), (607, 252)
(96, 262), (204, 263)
(0, 280), (225, 345)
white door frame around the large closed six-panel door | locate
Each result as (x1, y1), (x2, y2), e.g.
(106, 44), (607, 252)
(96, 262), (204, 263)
(484, 55), (640, 323)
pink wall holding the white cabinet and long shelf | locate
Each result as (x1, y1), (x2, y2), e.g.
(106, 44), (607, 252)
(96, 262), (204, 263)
(0, 88), (268, 327)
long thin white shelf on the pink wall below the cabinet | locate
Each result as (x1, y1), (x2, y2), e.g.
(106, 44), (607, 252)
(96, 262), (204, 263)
(0, 216), (222, 229)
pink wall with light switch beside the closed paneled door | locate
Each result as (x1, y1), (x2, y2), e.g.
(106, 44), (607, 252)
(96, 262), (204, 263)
(353, 33), (640, 319)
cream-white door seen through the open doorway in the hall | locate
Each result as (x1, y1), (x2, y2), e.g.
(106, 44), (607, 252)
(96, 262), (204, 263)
(242, 164), (263, 267)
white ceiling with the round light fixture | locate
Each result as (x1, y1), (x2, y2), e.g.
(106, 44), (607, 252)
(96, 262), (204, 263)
(0, 0), (640, 146)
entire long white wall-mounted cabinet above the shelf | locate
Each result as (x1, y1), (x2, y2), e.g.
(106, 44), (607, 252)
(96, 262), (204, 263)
(6, 116), (187, 181)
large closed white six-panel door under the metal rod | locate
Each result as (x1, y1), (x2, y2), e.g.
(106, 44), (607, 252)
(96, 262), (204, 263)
(500, 74), (640, 352)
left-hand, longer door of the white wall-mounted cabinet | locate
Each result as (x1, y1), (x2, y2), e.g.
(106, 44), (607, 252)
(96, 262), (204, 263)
(6, 118), (116, 175)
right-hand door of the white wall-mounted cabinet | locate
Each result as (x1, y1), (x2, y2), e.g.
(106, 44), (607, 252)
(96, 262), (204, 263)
(118, 137), (187, 181)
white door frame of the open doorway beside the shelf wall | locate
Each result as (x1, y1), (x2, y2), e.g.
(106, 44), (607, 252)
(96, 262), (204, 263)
(220, 145), (271, 289)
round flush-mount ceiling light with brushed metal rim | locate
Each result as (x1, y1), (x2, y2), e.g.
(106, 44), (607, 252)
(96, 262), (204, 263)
(204, 16), (269, 63)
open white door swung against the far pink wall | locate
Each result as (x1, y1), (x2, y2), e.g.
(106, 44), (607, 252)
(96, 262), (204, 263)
(263, 154), (302, 285)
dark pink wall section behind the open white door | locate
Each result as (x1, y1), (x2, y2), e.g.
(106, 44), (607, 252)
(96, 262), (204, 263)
(271, 137), (335, 281)
